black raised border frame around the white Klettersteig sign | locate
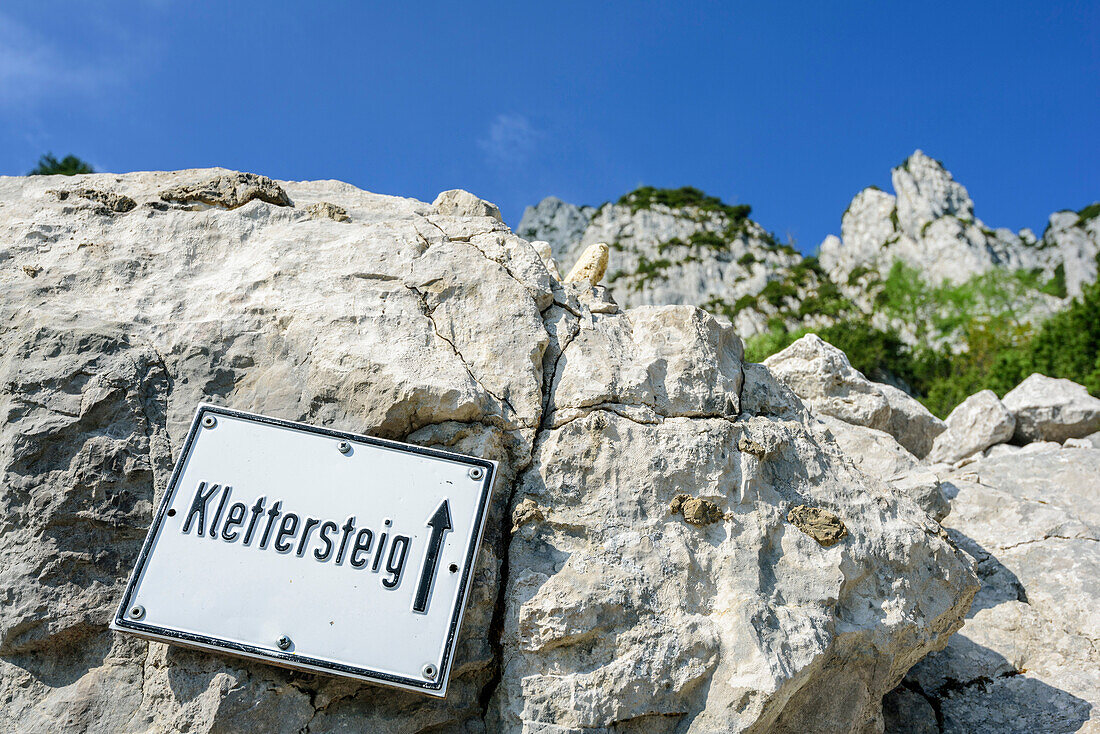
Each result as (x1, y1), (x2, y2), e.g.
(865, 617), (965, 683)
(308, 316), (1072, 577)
(110, 403), (497, 698)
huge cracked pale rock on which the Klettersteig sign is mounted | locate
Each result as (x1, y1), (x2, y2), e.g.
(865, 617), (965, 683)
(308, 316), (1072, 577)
(0, 169), (981, 734)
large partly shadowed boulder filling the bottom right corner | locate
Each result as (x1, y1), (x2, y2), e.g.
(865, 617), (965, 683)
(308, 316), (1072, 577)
(886, 447), (1100, 734)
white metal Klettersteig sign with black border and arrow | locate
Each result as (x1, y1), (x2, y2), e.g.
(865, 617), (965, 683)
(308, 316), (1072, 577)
(111, 405), (496, 697)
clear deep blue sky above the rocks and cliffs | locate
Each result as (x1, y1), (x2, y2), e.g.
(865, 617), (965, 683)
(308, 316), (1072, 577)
(0, 0), (1100, 251)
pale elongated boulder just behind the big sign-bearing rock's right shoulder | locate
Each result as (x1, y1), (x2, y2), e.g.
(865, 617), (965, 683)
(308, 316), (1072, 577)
(763, 333), (946, 459)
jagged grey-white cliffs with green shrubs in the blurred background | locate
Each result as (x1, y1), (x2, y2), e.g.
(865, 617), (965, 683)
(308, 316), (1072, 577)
(517, 151), (1100, 343)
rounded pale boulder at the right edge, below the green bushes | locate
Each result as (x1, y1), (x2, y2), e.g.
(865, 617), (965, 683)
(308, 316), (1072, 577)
(1004, 372), (1100, 443)
